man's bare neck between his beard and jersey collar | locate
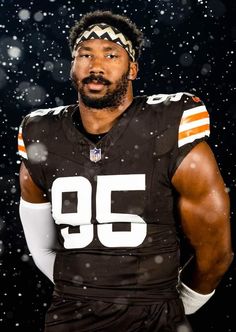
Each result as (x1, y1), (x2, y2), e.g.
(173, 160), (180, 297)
(79, 89), (133, 134)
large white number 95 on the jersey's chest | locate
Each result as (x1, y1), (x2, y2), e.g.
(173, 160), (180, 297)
(52, 174), (147, 249)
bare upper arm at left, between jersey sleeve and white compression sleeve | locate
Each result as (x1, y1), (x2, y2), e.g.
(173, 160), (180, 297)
(19, 162), (48, 203)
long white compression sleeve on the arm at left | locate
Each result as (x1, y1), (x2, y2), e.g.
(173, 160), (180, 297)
(19, 198), (56, 282)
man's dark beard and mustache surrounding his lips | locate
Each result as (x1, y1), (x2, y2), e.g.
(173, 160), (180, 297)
(73, 70), (129, 109)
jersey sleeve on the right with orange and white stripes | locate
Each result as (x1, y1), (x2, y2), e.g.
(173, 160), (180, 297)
(169, 93), (210, 178)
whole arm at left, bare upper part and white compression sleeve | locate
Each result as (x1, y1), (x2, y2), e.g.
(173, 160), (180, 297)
(20, 163), (57, 282)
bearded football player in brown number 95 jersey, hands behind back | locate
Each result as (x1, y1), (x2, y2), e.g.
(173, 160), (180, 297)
(19, 11), (232, 332)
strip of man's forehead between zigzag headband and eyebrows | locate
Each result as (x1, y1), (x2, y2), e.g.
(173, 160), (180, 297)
(78, 39), (128, 55)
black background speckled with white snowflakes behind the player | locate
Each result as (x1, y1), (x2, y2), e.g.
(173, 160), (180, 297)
(0, 0), (236, 332)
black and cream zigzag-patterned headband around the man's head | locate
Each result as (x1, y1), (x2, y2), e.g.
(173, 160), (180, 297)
(72, 23), (135, 61)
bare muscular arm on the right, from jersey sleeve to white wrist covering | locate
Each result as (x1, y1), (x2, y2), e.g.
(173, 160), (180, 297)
(172, 143), (233, 294)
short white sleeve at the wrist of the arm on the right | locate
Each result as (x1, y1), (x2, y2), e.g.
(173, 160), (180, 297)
(178, 282), (215, 315)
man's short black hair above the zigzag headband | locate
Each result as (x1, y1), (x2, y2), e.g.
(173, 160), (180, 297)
(69, 10), (143, 60)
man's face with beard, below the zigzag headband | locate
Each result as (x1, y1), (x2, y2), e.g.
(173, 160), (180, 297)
(71, 39), (134, 109)
